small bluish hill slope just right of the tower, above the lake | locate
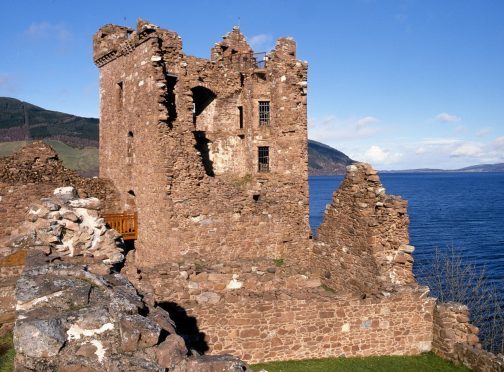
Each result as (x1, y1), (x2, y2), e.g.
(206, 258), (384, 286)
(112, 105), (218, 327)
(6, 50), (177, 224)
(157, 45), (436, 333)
(308, 140), (355, 176)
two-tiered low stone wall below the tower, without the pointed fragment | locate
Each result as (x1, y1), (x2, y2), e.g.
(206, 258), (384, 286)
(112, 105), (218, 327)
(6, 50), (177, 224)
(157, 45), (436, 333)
(123, 252), (435, 363)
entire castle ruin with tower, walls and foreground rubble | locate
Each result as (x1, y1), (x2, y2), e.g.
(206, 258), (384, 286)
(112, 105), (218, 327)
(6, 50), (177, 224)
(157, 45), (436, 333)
(0, 20), (504, 371)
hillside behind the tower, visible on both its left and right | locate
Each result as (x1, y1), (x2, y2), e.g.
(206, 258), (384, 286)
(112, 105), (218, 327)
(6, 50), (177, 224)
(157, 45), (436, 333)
(0, 97), (354, 176)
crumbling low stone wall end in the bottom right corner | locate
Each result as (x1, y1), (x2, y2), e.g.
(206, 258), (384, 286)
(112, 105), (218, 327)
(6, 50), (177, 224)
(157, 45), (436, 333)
(432, 302), (504, 372)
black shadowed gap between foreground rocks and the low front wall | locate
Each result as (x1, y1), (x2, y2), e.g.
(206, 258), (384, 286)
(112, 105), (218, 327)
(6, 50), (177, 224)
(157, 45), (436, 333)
(158, 302), (209, 354)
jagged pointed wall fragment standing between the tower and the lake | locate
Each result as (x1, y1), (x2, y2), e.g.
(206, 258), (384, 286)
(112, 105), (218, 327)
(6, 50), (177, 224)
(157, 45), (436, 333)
(313, 163), (414, 294)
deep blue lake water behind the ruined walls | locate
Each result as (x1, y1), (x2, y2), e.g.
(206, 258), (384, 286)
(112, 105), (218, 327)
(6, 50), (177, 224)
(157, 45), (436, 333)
(309, 173), (504, 290)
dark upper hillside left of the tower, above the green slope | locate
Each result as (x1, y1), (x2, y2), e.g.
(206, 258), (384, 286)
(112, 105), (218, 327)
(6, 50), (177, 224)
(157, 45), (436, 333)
(0, 97), (98, 147)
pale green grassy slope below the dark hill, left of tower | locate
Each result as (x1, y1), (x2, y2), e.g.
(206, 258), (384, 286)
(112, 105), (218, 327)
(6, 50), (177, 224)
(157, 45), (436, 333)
(0, 140), (99, 171)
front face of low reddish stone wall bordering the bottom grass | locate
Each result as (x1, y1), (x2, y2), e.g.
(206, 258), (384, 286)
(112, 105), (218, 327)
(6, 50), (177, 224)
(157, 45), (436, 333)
(176, 291), (434, 363)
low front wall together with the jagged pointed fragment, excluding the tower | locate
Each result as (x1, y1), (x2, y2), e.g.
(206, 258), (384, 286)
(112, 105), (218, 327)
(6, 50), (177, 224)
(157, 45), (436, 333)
(119, 164), (434, 362)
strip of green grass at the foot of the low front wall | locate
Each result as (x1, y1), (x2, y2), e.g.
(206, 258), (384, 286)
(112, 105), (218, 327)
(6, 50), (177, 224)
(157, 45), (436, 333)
(251, 353), (469, 372)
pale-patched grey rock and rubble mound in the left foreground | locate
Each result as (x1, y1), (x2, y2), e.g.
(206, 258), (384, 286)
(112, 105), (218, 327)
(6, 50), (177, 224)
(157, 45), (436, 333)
(10, 187), (246, 371)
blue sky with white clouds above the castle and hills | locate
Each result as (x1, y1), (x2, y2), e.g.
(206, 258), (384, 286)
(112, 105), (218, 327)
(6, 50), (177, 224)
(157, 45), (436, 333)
(0, 0), (504, 169)
